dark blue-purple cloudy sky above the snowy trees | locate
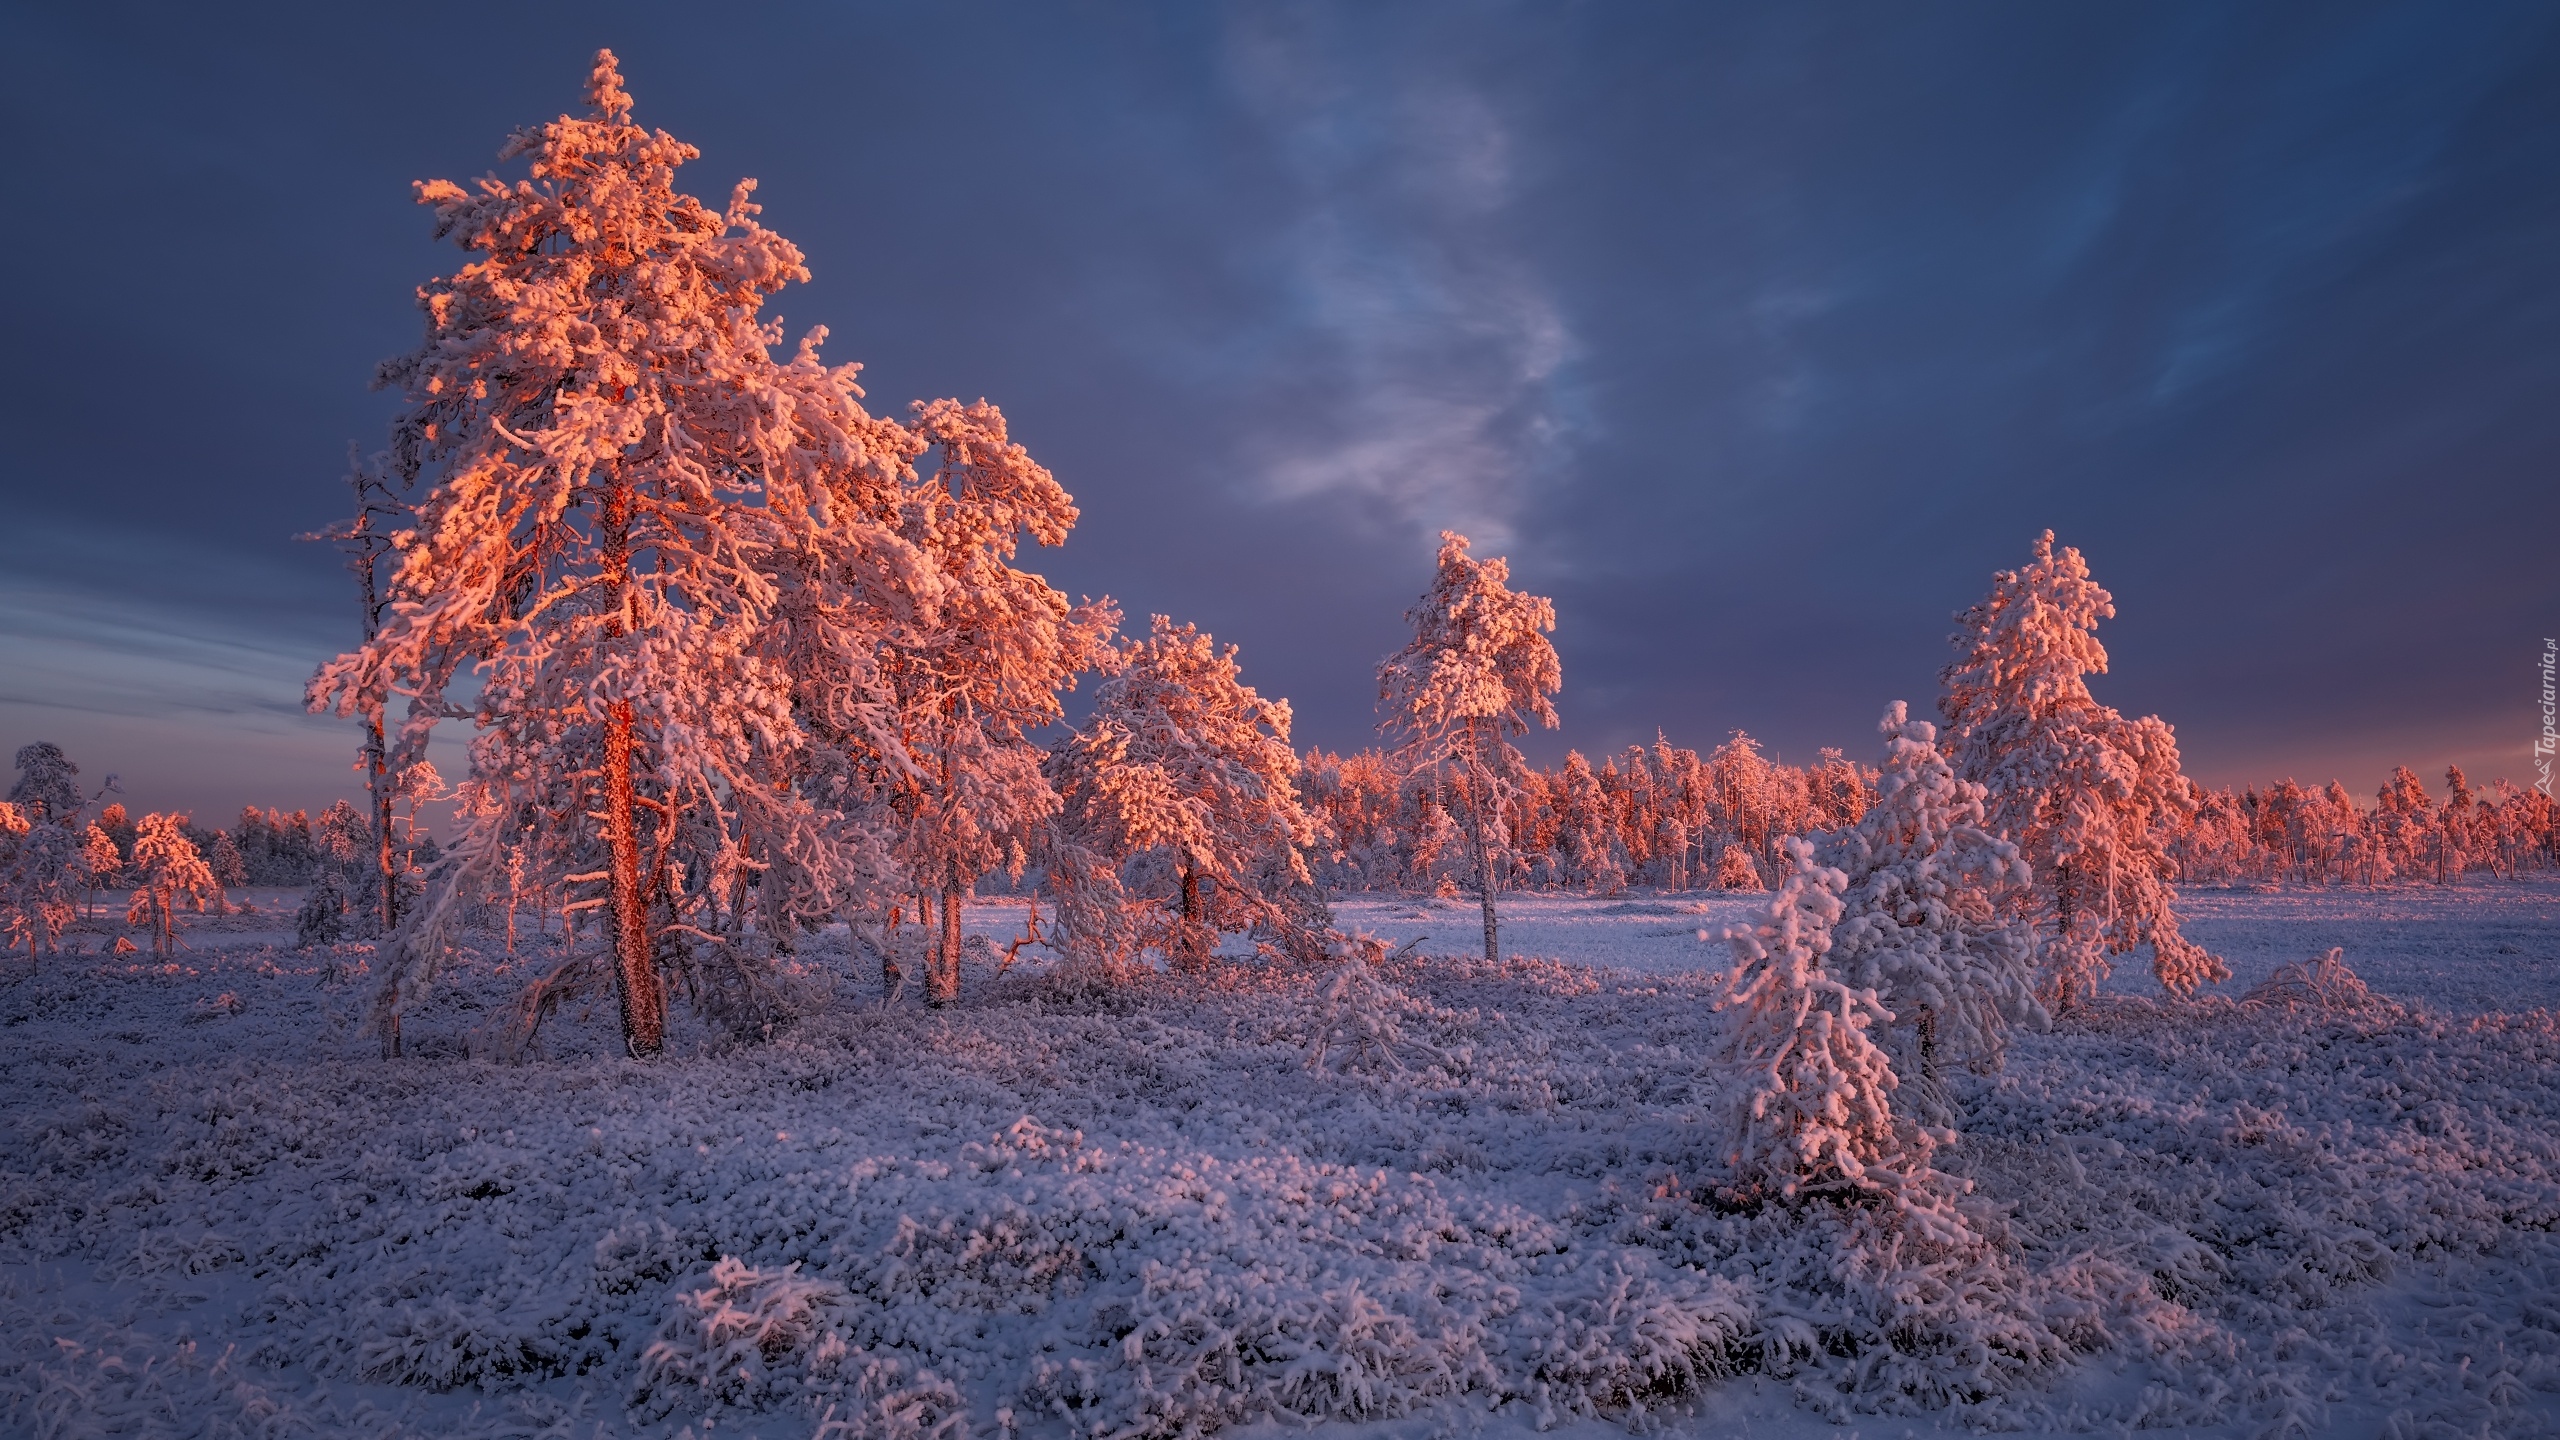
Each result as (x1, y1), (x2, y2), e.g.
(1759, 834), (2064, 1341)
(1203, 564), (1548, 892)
(0, 3), (2560, 817)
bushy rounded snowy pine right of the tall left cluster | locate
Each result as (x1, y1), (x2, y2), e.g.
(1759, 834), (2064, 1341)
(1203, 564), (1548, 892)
(1047, 615), (1316, 966)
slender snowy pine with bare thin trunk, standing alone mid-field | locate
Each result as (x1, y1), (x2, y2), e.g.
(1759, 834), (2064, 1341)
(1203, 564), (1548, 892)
(1377, 530), (1564, 961)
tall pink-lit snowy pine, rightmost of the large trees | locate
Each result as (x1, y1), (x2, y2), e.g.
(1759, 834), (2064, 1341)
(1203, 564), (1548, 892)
(1938, 530), (2230, 1007)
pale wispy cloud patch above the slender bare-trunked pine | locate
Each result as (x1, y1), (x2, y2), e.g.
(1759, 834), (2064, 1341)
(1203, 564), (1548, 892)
(1226, 13), (1574, 546)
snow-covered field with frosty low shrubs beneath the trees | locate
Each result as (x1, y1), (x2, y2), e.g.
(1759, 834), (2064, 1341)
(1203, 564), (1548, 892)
(0, 879), (2560, 1440)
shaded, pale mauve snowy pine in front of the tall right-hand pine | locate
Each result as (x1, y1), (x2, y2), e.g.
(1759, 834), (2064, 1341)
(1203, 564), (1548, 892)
(1818, 700), (2045, 1079)
